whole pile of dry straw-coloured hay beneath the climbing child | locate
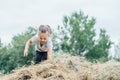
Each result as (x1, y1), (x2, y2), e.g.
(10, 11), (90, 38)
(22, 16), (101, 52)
(0, 55), (120, 80)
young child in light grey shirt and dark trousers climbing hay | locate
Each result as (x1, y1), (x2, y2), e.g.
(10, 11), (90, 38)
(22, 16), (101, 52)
(24, 25), (53, 64)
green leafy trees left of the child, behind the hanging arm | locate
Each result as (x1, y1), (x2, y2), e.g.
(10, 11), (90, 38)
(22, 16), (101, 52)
(0, 27), (36, 73)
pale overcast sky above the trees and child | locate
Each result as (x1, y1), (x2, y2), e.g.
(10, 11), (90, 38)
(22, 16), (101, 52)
(0, 0), (120, 44)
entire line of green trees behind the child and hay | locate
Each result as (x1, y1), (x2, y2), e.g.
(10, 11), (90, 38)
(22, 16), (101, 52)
(0, 11), (112, 73)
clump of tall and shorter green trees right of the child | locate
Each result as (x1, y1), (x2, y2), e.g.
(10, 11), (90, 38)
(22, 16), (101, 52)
(58, 11), (111, 59)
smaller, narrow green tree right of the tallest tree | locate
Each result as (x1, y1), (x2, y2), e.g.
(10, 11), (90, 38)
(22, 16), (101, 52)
(85, 29), (112, 60)
